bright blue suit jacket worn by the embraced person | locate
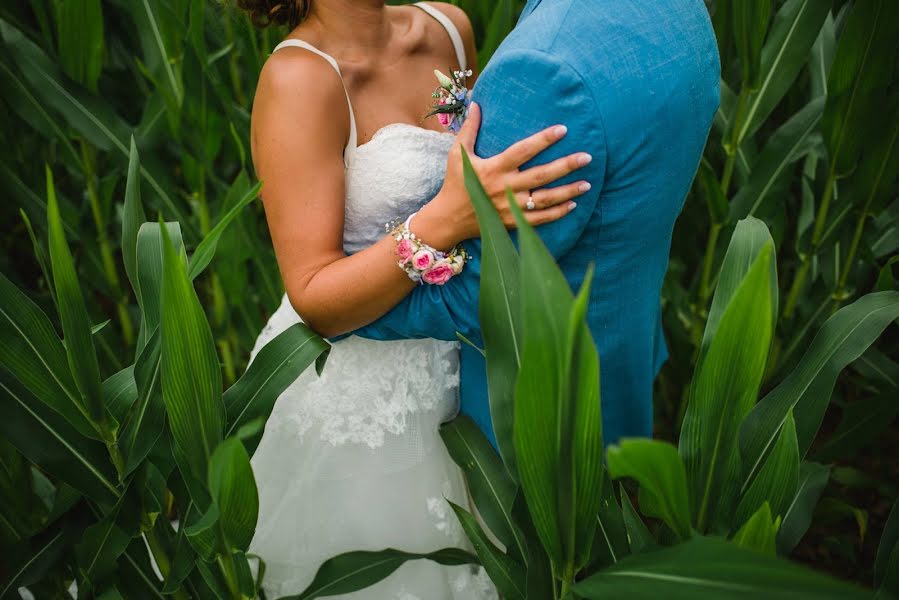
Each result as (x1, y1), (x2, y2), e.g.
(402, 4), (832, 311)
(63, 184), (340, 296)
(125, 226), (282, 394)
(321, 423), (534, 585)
(354, 0), (720, 445)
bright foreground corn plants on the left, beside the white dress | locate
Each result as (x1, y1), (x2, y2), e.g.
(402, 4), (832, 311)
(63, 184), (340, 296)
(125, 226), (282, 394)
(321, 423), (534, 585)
(0, 140), (328, 598)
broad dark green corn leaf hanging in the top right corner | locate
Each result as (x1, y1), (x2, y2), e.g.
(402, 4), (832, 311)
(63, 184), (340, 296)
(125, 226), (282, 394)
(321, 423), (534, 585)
(822, 0), (899, 178)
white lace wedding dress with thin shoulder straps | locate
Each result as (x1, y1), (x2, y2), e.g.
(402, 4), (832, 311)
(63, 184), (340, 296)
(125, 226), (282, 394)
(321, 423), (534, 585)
(249, 5), (496, 600)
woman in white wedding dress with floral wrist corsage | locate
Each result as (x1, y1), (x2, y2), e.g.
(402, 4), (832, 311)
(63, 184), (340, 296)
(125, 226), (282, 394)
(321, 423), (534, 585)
(238, 0), (586, 600)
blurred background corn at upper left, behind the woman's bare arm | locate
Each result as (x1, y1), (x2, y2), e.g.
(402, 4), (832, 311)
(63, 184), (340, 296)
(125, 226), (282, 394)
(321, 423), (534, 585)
(0, 0), (282, 383)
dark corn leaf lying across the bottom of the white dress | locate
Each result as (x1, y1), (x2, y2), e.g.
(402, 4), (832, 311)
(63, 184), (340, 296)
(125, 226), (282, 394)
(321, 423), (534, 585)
(281, 548), (477, 600)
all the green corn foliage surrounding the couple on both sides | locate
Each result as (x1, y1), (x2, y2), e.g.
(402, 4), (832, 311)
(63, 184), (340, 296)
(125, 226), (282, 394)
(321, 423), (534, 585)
(0, 0), (899, 600)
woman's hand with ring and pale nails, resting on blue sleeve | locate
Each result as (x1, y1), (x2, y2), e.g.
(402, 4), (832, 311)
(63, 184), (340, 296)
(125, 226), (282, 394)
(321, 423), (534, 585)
(413, 104), (592, 248)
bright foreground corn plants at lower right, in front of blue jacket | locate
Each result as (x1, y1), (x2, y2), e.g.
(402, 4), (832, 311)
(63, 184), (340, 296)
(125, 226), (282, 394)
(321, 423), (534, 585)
(416, 152), (899, 598)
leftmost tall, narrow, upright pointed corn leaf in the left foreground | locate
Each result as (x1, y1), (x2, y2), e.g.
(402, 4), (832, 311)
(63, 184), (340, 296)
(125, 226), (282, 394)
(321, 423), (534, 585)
(47, 167), (109, 432)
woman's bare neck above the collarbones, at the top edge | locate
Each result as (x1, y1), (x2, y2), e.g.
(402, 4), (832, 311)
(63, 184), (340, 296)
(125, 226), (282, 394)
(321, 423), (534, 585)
(305, 0), (391, 51)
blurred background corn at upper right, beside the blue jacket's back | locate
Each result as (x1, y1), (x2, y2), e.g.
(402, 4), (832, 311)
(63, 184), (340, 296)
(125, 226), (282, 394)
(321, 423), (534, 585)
(660, 0), (899, 432)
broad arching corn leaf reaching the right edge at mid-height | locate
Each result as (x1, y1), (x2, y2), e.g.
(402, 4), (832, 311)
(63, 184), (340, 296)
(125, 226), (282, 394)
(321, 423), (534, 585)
(740, 292), (899, 489)
